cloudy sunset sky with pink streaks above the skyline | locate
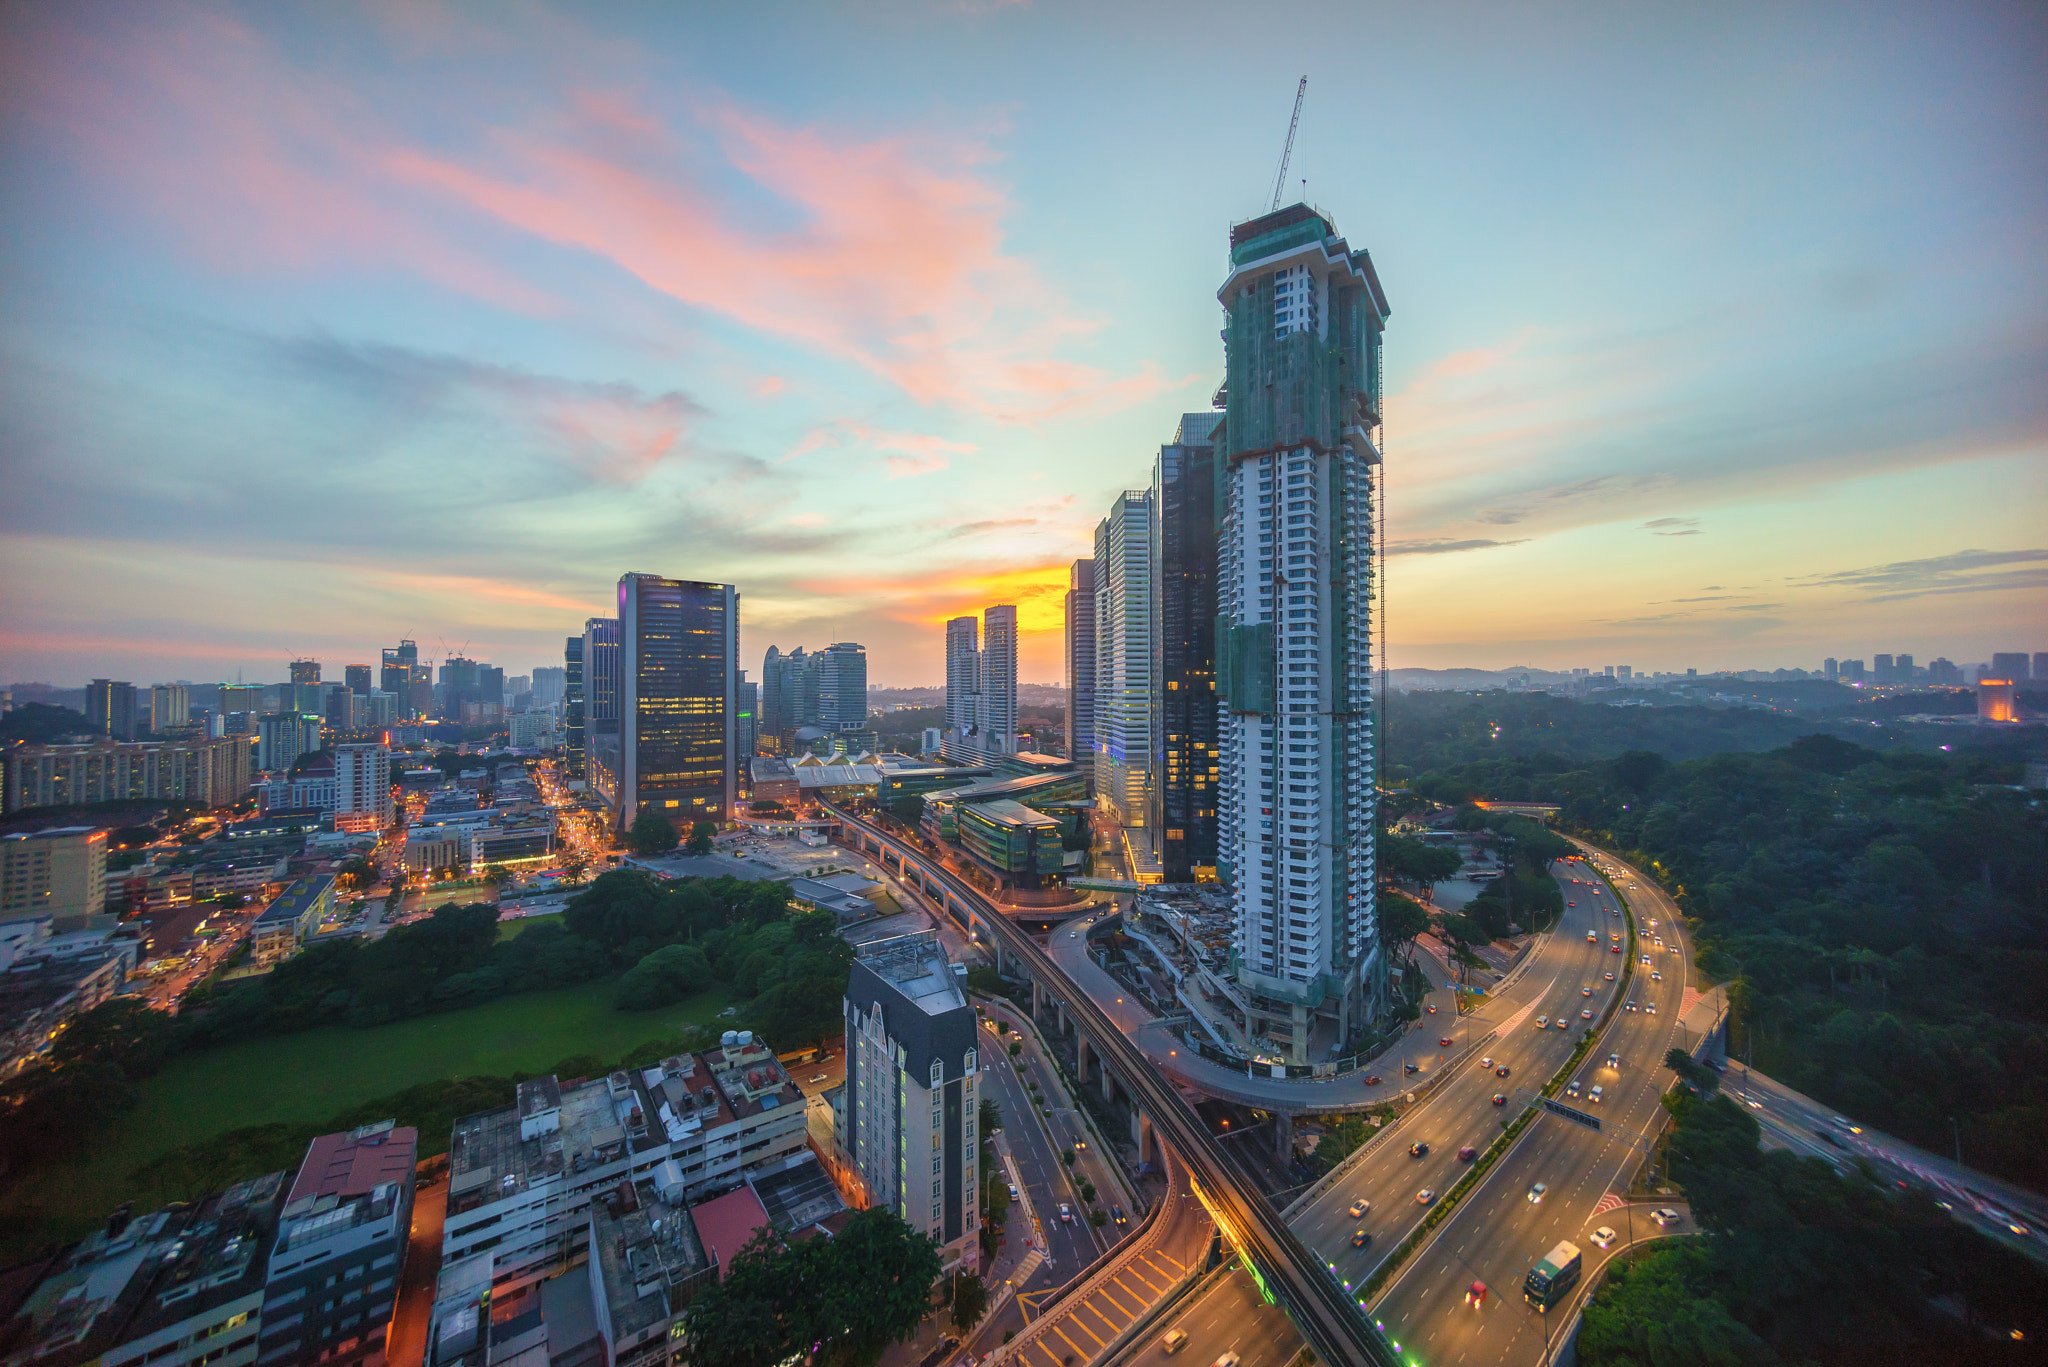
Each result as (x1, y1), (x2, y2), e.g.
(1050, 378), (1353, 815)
(0, 0), (2048, 687)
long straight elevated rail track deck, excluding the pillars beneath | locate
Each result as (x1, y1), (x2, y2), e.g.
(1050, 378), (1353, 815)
(823, 803), (1397, 1367)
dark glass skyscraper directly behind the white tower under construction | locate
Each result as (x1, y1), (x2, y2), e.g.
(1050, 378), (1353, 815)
(1151, 412), (1223, 883)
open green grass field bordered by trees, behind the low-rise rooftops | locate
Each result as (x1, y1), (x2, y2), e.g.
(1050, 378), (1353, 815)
(0, 971), (727, 1248)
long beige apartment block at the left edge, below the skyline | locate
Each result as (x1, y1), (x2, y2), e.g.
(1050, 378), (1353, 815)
(0, 736), (250, 812)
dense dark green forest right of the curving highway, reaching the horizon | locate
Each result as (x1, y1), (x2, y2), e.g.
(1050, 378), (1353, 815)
(1391, 695), (2048, 1189)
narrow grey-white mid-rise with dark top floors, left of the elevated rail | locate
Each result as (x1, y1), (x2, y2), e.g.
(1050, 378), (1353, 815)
(838, 930), (981, 1273)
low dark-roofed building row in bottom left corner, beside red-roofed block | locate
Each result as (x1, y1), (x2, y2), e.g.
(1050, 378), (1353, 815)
(0, 1172), (285, 1367)
